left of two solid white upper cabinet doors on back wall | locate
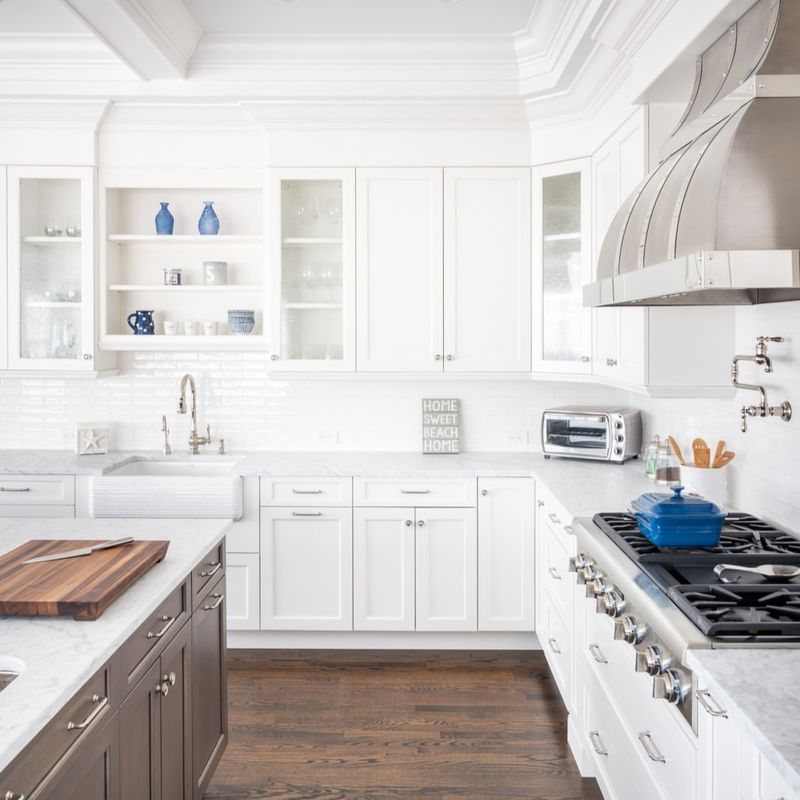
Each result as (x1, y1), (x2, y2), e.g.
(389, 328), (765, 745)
(356, 168), (444, 372)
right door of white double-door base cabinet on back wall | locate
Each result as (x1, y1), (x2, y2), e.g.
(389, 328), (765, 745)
(415, 508), (478, 631)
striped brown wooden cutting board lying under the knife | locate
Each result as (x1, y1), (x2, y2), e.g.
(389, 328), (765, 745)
(0, 539), (169, 620)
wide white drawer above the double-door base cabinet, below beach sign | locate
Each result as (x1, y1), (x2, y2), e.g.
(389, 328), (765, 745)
(353, 476), (478, 508)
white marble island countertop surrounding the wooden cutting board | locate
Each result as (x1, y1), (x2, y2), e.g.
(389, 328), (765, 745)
(0, 518), (229, 772)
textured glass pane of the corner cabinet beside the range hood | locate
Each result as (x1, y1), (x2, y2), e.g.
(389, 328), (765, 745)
(541, 172), (584, 361)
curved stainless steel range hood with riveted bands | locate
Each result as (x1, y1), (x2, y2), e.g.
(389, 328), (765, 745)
(584, 0), (800, 306)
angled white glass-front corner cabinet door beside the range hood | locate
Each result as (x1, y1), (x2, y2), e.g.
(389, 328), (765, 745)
(533, 159), (592, 374)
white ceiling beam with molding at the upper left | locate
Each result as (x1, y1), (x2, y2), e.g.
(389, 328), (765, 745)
(62, 0), (203, 81)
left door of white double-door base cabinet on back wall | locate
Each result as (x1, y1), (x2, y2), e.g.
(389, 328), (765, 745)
(353, 508), (422, 631)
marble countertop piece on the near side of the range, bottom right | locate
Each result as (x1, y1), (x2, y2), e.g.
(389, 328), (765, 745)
(686, 648), (800, 794)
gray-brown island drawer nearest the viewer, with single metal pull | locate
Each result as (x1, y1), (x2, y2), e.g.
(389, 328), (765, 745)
(0, 666), (112, 798)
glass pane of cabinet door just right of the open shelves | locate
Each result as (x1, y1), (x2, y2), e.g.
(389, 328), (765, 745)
(281, 180), (344, 361)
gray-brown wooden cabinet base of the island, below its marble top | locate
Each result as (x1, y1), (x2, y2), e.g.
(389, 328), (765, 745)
(0, 541), (228, 800)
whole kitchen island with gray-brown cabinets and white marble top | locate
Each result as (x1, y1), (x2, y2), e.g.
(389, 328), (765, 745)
(0, 518), (228, 800)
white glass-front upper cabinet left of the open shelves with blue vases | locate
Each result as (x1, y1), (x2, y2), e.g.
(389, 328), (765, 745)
(7, 167), (97, 371)
